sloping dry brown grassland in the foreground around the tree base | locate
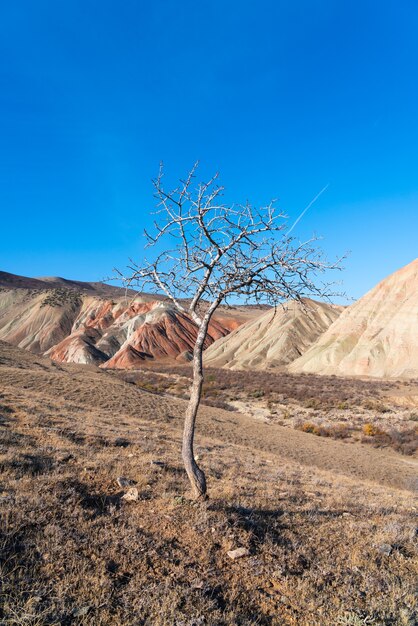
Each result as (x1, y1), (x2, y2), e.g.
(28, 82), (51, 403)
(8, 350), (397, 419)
(0, 342), (418, 626)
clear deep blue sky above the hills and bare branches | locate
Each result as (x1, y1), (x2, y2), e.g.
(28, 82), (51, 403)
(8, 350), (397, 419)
(0, 0), (418, 298)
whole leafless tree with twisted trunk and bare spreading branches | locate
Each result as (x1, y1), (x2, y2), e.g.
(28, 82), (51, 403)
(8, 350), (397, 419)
(118, 163), (339, 498)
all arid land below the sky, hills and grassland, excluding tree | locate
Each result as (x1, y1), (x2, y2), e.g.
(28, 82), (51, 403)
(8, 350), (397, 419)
(0, 262), (418, 626)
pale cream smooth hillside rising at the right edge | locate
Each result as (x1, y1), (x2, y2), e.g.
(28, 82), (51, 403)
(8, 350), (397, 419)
(289, 259), (418, 378)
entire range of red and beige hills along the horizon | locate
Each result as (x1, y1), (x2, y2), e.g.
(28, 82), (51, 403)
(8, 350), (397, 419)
(0, 259), (418, 380)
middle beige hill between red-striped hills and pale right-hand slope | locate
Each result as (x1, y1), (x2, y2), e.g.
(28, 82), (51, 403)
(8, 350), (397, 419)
(204, 299), (341, 369)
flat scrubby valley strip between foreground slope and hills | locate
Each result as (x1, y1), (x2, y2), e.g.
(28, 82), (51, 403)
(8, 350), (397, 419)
(116, 363), (418, 456)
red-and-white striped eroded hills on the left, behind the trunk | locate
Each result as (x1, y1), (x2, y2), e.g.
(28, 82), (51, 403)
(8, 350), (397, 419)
(0, 272), (260, 368)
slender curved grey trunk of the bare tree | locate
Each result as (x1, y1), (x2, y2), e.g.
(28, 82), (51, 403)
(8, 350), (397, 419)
(182, 319), (209, 500)
